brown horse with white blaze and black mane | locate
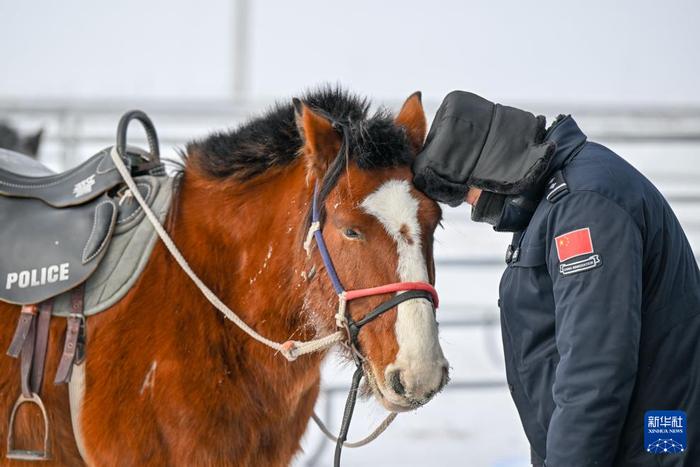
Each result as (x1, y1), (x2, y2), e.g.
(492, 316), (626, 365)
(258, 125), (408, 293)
(0, 88), (447, 466)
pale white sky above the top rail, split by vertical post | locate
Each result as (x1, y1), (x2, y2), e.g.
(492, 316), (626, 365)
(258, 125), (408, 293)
(0, 0), (700, 105)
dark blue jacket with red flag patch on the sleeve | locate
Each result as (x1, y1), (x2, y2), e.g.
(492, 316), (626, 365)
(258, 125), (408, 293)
(499, 117), (700, 467)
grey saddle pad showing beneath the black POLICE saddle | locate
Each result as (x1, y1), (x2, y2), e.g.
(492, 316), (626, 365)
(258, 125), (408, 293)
(53, 176), (177, 316)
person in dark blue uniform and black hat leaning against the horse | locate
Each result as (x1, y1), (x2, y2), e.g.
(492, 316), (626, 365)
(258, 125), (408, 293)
(414, 91), (700, 467)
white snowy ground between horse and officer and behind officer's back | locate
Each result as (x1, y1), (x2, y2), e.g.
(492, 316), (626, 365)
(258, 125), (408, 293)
(294, 143), (700, 467)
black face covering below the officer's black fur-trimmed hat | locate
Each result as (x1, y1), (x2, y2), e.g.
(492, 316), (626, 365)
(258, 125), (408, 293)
(472, 191), (538, 232)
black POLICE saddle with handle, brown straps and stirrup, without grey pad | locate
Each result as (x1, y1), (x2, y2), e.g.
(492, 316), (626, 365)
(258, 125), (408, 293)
(0, 110), (164, 461)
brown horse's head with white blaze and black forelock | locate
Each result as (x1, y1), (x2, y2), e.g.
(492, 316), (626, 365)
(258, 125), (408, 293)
(295, 93), (448, 411)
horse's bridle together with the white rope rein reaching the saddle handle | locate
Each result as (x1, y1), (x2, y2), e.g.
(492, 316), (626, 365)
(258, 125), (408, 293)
(110, 112), (438, 467)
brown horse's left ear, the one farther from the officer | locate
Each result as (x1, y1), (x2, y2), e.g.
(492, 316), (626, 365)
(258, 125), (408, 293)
(292, 98), (341, 178)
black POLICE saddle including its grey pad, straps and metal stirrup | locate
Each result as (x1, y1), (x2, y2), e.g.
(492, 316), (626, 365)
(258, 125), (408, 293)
(0, 111), (172, 461)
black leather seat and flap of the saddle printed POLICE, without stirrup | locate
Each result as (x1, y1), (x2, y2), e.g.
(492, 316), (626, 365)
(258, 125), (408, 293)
(0, 112), (163, 305)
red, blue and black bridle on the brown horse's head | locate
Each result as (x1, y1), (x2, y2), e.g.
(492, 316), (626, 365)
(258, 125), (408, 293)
(304, 121), (439, 467)
